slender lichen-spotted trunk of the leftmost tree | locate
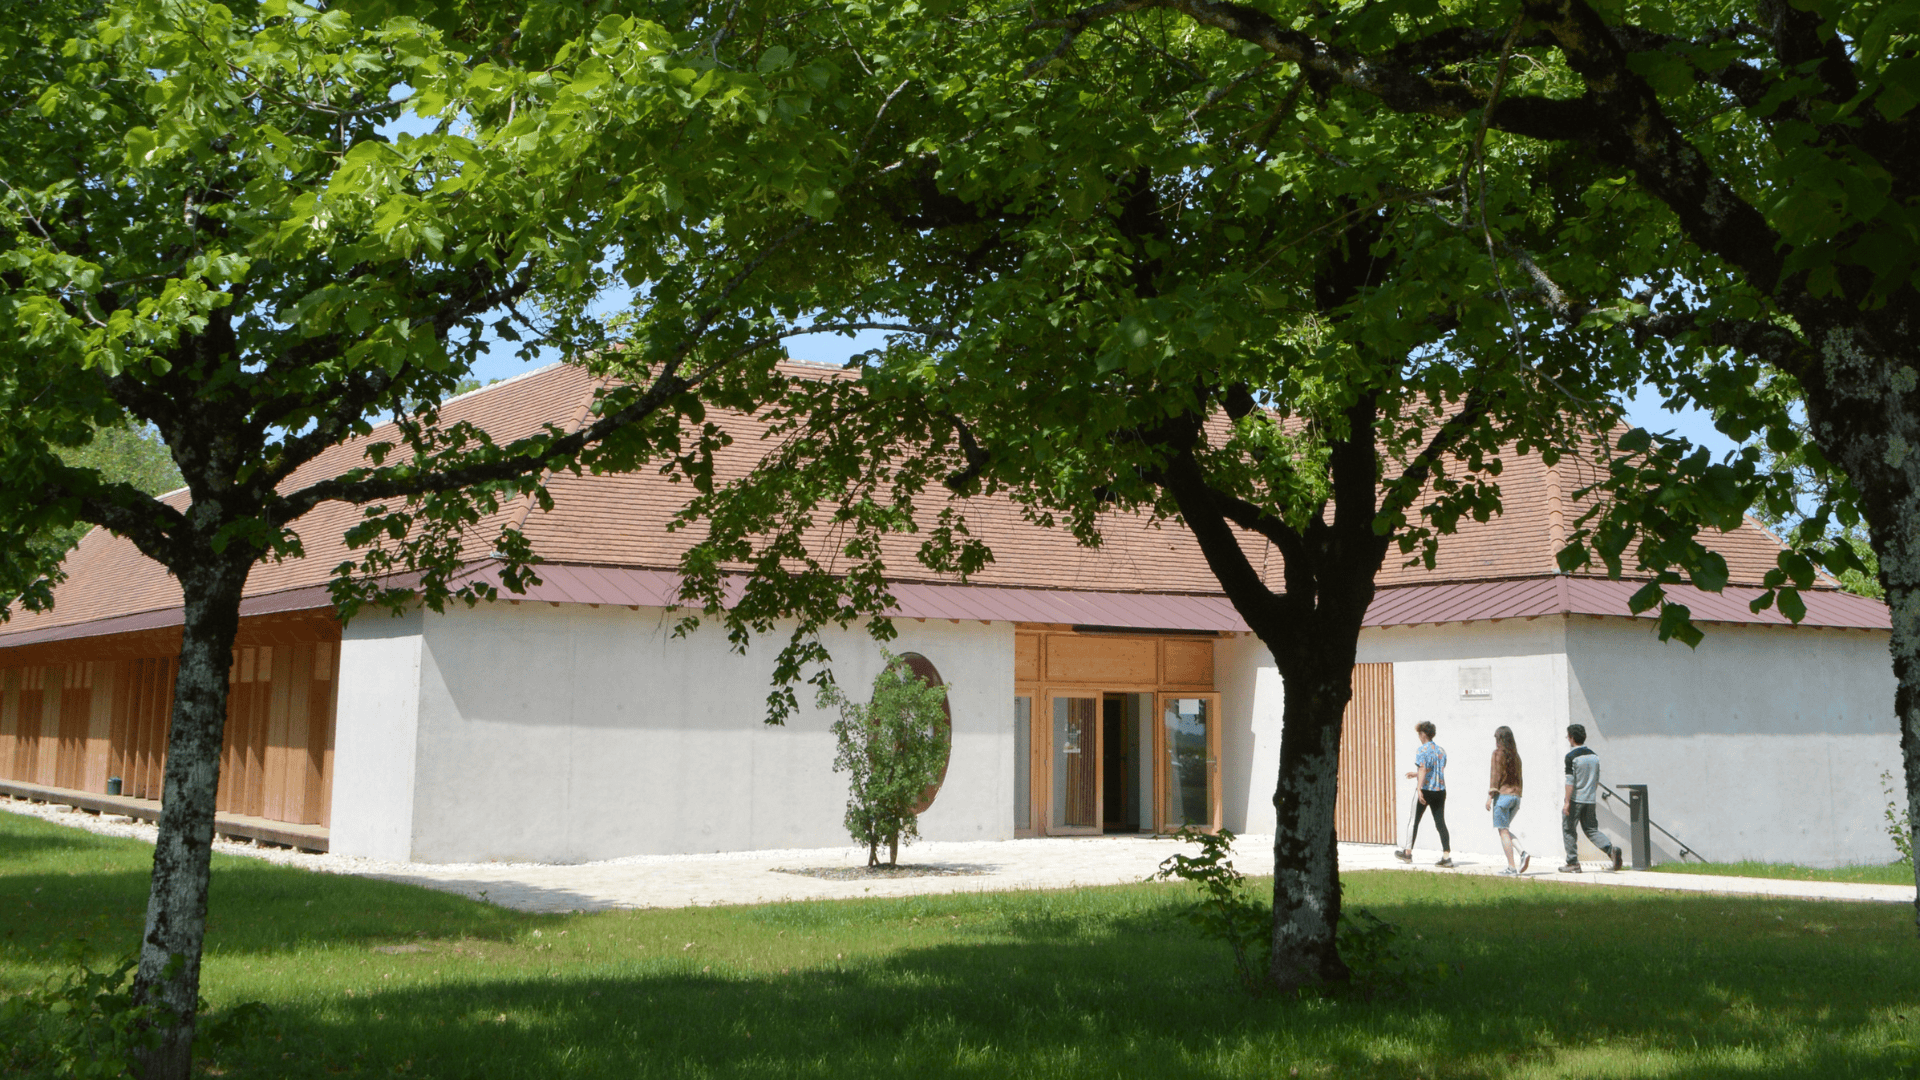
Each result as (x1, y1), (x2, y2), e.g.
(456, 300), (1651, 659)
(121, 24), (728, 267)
(134, 553), (252, 1080)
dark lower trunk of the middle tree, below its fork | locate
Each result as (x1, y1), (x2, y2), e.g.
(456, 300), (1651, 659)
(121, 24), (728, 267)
(1267, 642), (1354, 990)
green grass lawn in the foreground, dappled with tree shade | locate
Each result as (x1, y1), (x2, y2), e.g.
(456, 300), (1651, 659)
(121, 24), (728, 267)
(0, 813), (1920, 1080)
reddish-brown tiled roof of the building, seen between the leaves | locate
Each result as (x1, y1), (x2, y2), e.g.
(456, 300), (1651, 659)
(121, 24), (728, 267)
(0, 365), (1858, 648)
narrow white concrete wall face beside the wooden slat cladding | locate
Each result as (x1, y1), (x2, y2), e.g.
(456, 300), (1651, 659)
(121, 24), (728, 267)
(328, 611), (422, 861)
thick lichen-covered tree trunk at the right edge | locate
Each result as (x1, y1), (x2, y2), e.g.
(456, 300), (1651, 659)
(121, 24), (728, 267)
(1801, 327), (1920, 932)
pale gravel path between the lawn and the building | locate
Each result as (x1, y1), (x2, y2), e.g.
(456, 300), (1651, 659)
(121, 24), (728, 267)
(0, 799), (1914, 911)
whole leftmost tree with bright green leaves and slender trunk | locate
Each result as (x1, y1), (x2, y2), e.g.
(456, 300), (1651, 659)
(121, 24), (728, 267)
(0, 0), (906, 1076)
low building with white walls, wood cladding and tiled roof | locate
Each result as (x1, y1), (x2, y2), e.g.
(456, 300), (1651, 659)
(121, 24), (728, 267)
(0, 365), (1899, 865)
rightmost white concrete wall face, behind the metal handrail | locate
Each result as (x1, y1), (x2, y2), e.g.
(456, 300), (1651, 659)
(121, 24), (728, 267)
(1567, 619), (1901, 867)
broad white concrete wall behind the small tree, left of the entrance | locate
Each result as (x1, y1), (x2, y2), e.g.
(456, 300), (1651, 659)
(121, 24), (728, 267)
(362, 603), (1014, 863)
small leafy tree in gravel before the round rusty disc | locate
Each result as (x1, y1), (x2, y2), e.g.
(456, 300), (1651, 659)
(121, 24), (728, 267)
(820, 651), (948, 867)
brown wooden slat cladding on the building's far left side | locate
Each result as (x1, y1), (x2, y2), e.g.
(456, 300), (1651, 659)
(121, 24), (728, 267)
(0, 621), (340, 824)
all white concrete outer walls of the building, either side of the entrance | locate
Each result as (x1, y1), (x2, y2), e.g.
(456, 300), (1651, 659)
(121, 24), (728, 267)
(332, 591), (1899, 865)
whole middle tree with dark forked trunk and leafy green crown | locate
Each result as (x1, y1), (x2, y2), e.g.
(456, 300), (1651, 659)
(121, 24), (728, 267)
(689, 0), (1666, 986)
